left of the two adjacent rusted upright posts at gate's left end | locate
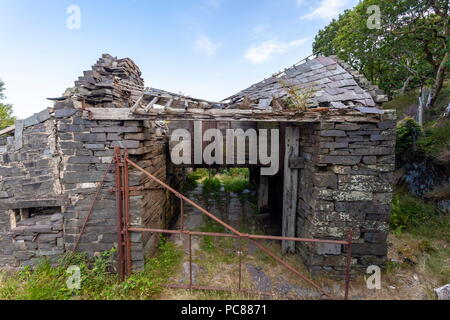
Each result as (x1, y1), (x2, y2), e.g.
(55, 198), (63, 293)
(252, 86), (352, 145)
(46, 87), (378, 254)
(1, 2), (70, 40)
(114, 148), (125, 281)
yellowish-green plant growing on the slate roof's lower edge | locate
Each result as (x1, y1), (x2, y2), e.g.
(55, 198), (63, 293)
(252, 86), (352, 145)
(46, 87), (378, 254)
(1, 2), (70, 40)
(280, 79), (317, 111)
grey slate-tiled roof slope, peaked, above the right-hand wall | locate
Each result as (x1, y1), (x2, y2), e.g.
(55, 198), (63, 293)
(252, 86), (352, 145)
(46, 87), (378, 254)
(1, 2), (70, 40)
(224, 56), (387, 113)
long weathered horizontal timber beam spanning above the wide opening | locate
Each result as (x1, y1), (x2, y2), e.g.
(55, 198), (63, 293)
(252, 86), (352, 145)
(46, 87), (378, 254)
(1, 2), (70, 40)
(84, 108), (395, 123)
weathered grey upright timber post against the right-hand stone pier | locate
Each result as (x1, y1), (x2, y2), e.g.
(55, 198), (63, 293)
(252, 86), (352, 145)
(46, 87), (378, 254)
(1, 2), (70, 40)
(282, 126), (300, 253)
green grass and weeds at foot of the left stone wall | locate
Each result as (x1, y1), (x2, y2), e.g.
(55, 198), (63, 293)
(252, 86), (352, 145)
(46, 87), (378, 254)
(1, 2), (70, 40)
(0, 241), (181, 300)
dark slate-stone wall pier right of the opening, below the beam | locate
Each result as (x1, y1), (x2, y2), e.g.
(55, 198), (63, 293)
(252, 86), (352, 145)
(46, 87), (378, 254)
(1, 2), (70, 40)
(297, 115), (395, 276)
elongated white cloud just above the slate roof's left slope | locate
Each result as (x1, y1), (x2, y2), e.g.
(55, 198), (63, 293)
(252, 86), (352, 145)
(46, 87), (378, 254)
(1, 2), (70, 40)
(245, 38), (308, 64)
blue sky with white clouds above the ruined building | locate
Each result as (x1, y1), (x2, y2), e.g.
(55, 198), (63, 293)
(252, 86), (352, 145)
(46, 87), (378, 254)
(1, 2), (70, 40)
(0, 0), (357, 118)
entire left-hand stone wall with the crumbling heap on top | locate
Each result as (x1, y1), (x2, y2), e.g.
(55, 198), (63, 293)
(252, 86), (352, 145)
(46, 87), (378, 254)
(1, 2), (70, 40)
(0, 55), (179, 270)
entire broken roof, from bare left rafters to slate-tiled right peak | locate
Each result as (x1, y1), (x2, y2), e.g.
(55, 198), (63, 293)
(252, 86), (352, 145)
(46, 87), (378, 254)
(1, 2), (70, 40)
(128, 56), (387, 114)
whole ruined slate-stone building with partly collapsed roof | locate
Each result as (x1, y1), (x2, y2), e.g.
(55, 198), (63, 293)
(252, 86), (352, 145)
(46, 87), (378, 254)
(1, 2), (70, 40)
(0, 54), (395, 274)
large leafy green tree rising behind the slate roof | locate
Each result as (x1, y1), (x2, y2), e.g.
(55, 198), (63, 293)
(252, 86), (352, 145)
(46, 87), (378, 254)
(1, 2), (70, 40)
(313, 0), (450, 104)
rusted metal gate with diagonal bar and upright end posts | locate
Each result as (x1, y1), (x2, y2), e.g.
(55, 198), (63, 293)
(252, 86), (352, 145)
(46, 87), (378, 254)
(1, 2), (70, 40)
(113, 147), (352, 300)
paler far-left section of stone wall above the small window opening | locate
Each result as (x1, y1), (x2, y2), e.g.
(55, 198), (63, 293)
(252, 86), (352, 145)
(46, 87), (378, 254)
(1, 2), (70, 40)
(0, 110), (64, 267)
